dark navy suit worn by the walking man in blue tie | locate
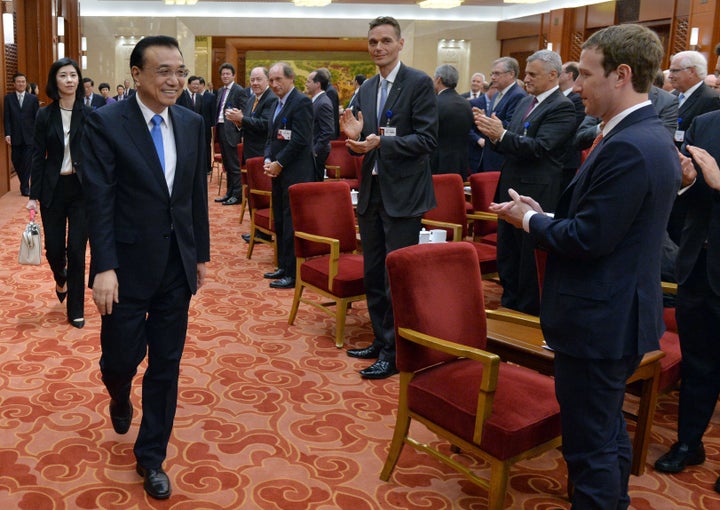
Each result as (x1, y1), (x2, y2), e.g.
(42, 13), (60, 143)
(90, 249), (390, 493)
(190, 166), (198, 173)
(82, 95), (210, 469)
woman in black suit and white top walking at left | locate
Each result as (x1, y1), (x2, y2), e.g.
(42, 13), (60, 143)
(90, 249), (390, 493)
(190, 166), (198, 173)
(27, 58), (91, 328)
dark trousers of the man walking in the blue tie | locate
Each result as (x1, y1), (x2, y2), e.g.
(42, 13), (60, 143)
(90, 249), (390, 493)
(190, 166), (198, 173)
(100, 239), (191, 469)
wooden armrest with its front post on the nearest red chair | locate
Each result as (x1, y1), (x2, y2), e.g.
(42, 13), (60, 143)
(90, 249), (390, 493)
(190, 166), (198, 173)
(398, 328), (500, 444)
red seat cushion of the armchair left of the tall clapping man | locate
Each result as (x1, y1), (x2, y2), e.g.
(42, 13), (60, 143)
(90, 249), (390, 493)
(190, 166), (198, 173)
(300, 253), (365, 297)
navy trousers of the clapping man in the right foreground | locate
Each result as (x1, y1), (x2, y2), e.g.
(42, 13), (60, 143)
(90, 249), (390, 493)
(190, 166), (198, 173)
(554, 350), (642, 510)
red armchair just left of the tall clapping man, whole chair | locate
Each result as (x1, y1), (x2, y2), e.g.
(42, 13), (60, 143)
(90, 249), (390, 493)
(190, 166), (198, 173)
(288, 181), (365, 348)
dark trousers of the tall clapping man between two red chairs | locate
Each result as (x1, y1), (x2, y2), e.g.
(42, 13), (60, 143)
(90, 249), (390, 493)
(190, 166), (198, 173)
(358, 177), (421, 361)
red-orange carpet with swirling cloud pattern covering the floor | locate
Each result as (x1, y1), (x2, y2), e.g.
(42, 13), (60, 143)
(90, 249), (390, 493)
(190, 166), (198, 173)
(0, 176), (720, 510)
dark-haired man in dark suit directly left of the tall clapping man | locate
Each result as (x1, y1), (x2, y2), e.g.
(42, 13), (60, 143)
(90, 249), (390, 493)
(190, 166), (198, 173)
(305, 71), (337, 181)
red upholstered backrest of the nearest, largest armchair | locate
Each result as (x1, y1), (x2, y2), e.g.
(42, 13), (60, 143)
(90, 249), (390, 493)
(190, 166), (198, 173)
(386, 243), (487, 371)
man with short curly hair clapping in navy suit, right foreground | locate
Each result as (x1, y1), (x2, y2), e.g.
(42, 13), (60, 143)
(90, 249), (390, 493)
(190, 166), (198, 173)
(491, 24), (681, 509)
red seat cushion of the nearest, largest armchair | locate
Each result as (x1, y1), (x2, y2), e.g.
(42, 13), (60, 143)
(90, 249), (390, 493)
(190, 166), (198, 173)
(408, 359), (560, 460)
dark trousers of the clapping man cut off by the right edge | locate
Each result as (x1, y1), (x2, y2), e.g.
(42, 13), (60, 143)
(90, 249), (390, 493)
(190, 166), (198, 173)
(676, 249), (720, 447)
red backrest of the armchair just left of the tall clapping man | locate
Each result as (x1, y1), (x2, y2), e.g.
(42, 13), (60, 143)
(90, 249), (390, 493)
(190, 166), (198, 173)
(289, 181), (357, 257)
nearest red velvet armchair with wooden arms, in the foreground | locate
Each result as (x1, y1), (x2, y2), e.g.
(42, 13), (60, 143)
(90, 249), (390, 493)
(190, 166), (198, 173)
(380, 243), (561, 510)
